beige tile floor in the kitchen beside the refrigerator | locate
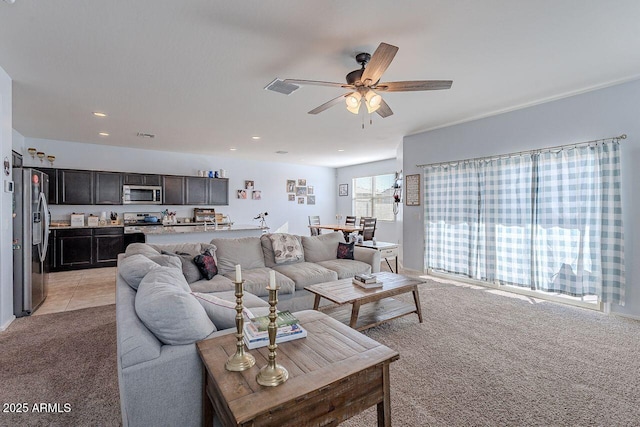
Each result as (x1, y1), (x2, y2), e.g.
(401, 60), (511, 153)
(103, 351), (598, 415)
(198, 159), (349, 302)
(33, 267), (116, 316)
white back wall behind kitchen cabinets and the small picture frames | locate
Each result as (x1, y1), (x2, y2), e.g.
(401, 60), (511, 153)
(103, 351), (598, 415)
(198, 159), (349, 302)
(22, 137), (336, 235)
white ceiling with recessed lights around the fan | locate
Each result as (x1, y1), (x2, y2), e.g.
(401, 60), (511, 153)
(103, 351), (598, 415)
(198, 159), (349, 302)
(0, 0), (640, 167)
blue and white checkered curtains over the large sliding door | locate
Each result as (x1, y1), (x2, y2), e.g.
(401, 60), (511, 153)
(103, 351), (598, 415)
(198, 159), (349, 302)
(424, 142), (625, 305)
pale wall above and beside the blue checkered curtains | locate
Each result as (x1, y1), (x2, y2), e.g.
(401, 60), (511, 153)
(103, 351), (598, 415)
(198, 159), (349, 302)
(403, 77), (640, 317)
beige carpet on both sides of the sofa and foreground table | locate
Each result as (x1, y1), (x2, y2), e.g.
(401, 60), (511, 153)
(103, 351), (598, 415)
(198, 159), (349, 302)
(0, 281), (640, 427)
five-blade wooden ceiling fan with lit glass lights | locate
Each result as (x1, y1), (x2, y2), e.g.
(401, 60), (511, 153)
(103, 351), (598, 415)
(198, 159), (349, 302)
(284, 43), (453, 118)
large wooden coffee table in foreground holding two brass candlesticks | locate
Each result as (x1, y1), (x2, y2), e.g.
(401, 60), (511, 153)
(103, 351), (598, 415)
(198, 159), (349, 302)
(196, 310), (399, 426)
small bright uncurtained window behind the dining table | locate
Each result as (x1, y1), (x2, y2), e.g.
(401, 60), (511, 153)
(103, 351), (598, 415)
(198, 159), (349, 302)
(352, 173), (395, 221)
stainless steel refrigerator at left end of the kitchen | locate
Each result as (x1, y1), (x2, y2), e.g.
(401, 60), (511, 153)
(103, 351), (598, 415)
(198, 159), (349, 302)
(13, 168), (50, 317)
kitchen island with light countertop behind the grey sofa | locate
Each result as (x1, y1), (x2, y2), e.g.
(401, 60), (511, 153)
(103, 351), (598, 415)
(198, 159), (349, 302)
(138, 224), (268, 244)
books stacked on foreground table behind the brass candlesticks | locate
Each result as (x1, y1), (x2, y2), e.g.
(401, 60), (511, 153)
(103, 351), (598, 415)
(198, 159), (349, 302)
(243, 311), (307, 350)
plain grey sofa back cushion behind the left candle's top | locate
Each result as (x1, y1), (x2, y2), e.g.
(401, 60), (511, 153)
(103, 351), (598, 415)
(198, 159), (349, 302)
(211, 237), (265, 277)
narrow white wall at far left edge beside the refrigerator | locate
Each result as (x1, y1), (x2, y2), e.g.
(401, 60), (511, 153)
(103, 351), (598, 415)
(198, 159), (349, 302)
(0, 68), (14, 331)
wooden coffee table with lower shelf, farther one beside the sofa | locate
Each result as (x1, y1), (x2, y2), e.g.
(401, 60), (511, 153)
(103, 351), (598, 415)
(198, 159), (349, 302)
(305, 272), (424, 331)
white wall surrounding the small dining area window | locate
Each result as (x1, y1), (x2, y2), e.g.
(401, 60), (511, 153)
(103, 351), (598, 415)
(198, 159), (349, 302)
(336, 159), (402, 244)
